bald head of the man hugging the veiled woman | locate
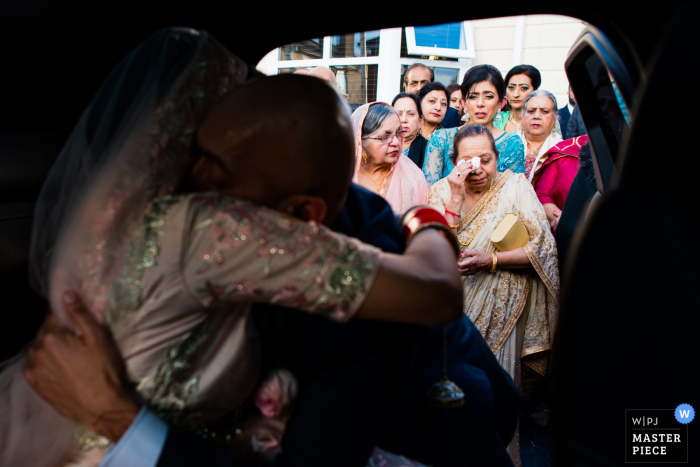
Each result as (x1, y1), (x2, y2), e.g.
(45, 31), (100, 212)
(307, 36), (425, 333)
(198, 74), (355, 222)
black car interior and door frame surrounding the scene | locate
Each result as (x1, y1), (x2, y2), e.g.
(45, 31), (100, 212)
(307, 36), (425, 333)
(0, 0), (700, 466)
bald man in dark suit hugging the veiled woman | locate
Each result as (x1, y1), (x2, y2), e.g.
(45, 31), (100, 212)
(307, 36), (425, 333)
(24, 75), (517, 467)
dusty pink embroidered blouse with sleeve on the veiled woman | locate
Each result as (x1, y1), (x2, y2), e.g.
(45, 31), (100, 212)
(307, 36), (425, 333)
(115, 193), (380, 427)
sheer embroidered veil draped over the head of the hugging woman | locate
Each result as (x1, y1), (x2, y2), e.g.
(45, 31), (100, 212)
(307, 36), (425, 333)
(30, 28), (247, 328)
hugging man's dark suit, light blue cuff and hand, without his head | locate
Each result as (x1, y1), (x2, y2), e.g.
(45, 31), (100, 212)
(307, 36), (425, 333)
(26, 186), (519, 467)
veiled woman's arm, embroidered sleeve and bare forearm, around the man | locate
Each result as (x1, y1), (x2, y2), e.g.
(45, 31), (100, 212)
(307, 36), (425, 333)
(182, 196), (462, 326)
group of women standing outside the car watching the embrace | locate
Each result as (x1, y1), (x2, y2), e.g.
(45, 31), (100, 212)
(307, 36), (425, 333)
(353, 65), (587, 465)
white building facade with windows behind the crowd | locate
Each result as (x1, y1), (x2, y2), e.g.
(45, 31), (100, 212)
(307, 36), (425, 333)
(257, 15), (584, 109)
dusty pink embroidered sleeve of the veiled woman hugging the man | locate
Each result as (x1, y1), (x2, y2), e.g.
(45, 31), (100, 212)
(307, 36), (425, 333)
(178, 194), (379, 321)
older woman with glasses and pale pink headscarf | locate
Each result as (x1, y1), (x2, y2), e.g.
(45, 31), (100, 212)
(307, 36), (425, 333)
(352, 102), (428, 214)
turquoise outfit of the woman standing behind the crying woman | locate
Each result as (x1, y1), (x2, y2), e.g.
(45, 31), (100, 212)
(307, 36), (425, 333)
(423, 128), (525, 185)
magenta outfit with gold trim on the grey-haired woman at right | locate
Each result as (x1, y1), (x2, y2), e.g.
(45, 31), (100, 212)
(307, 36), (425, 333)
(532, 135), (588, 232)
